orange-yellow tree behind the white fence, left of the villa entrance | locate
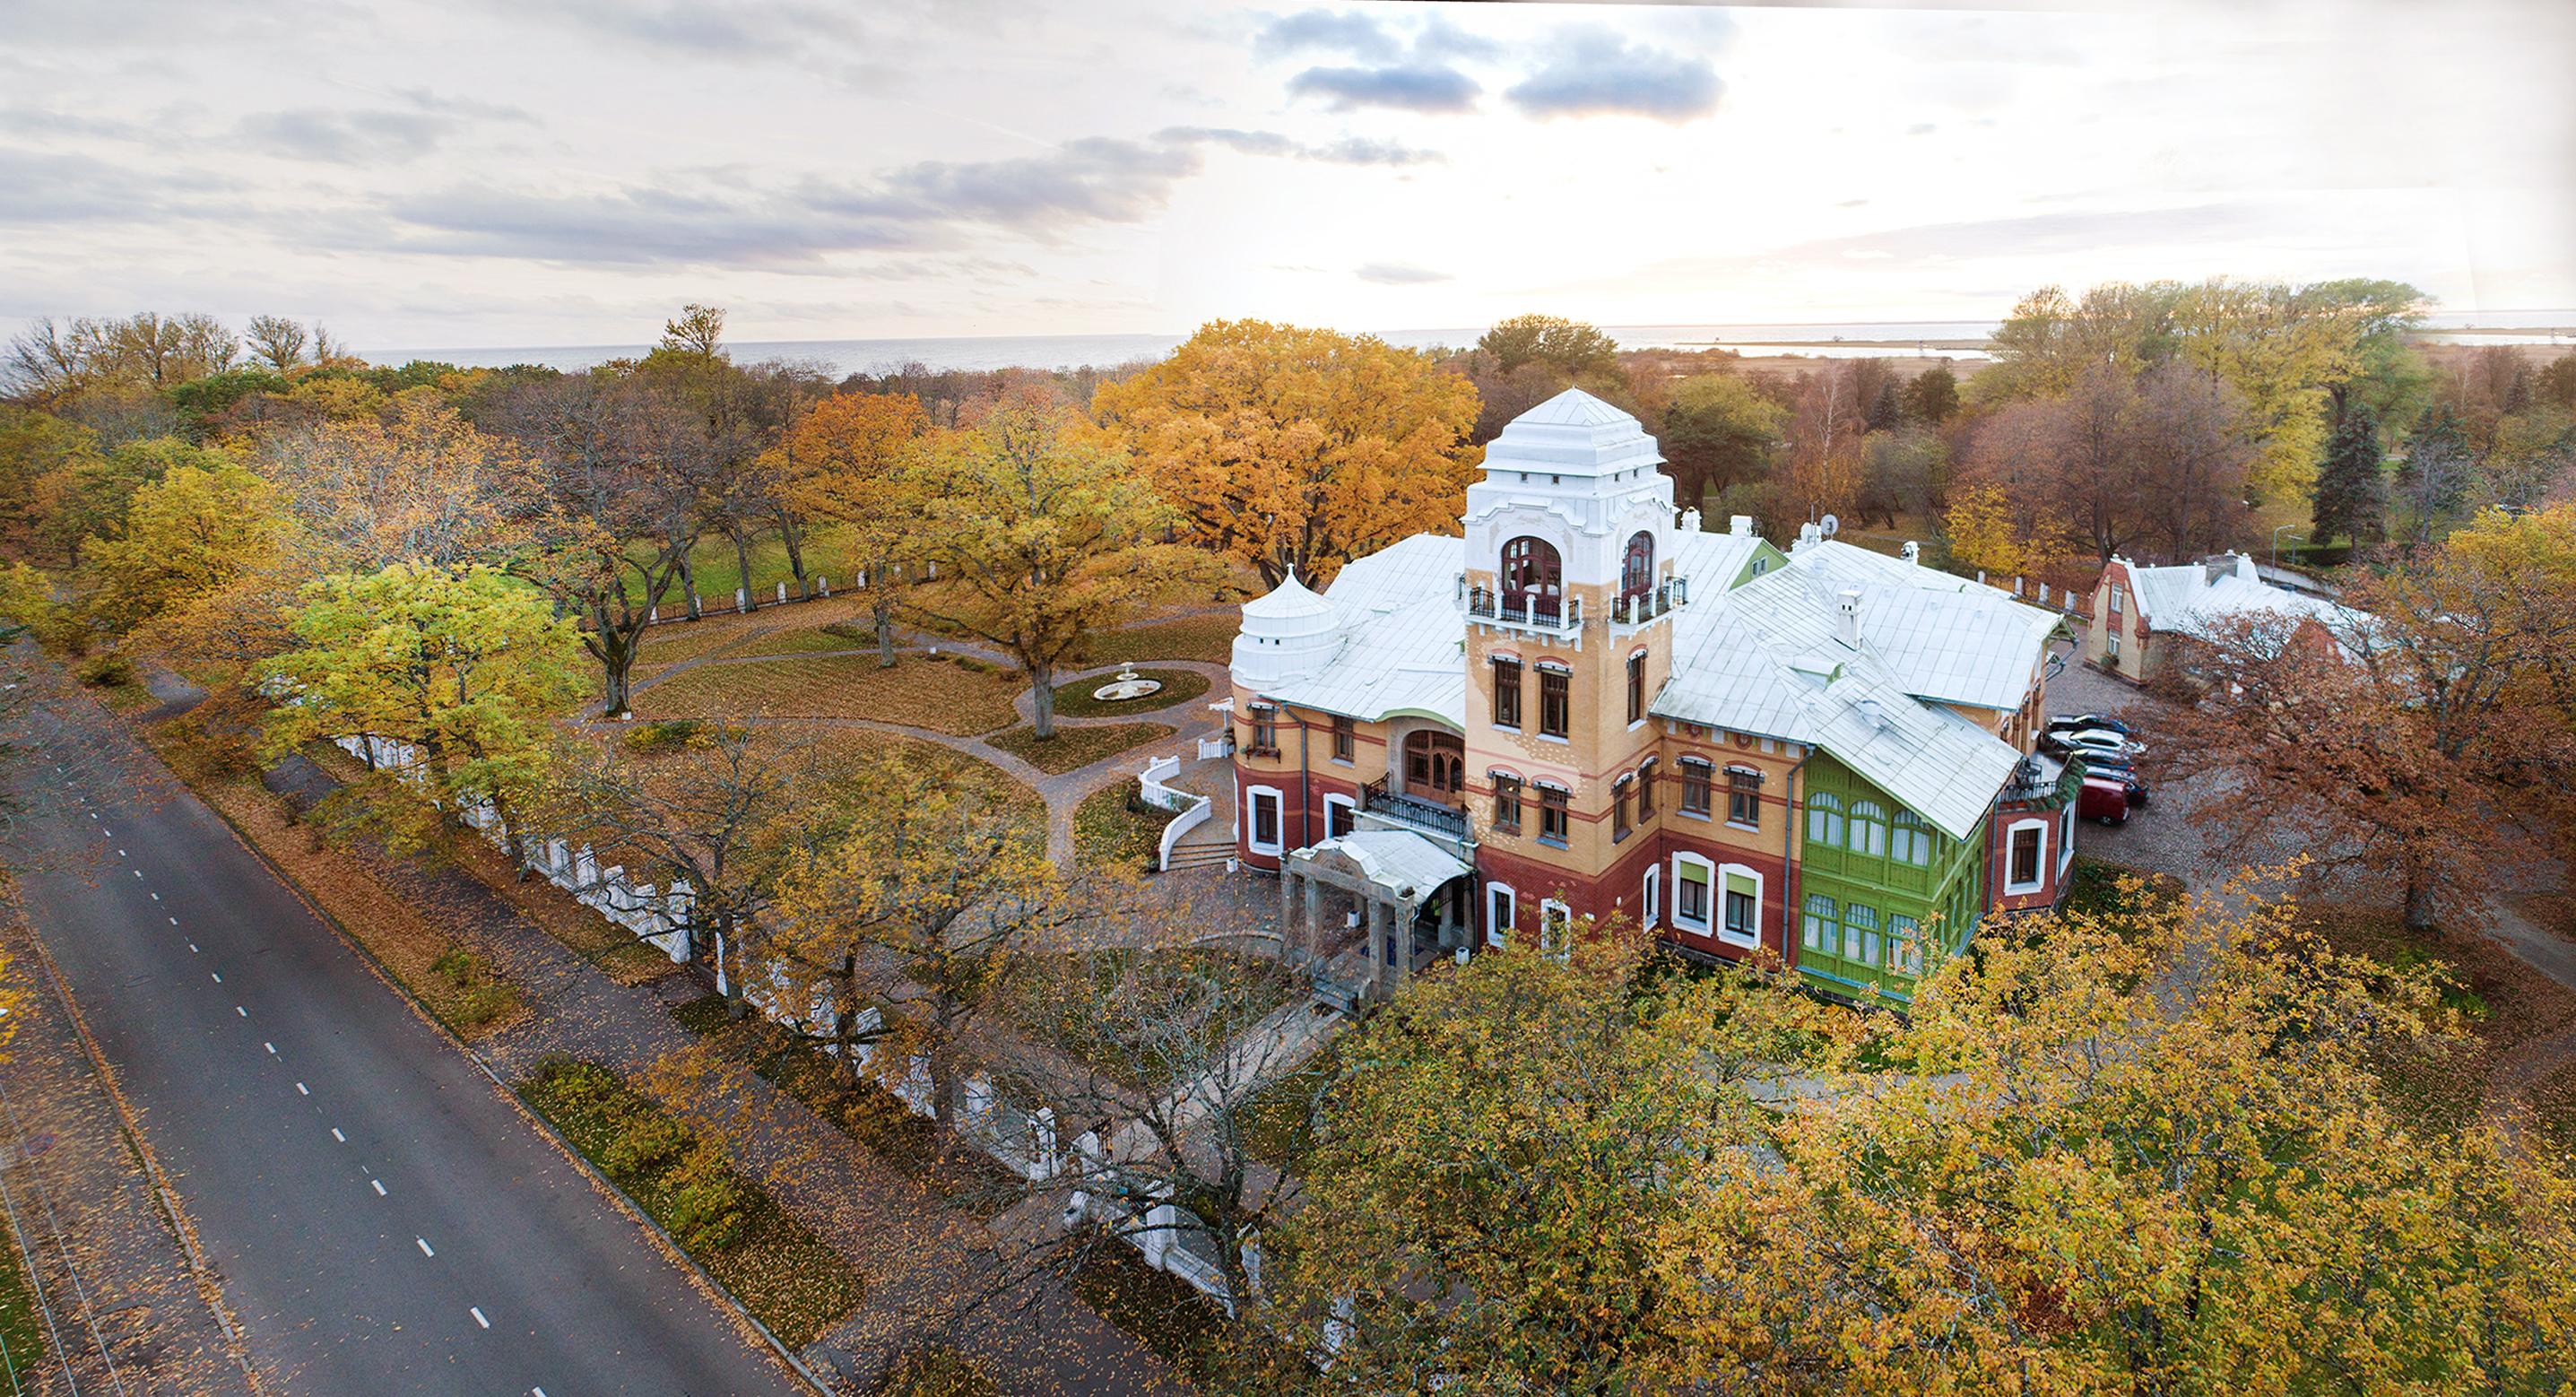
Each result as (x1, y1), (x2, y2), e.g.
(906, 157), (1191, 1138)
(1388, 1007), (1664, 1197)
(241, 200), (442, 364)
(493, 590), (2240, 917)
(760, 758), (1085, 1119)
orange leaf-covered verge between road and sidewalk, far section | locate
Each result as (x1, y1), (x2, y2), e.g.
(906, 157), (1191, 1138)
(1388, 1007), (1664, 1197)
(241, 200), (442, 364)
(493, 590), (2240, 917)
(147, 758), (528, 1041)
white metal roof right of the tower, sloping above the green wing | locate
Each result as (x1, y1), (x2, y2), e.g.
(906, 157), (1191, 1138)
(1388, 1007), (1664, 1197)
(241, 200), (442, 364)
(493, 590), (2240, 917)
(1653, 569), (2022, 837)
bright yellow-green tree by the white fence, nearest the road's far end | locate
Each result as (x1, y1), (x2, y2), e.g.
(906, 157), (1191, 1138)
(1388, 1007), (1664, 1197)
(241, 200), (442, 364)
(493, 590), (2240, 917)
(263, 562), (579, 861)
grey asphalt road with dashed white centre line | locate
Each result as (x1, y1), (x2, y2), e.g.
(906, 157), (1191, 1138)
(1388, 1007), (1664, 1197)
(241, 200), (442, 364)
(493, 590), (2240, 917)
(2, 704), (803, 1397)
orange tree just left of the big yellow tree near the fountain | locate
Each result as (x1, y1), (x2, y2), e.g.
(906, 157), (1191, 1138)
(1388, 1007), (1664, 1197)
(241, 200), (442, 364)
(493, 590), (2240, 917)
(776, 392), (927, 668)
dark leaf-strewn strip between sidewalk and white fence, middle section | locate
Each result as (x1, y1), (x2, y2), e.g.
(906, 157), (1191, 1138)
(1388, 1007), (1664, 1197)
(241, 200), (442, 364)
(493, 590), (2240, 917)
(670, 995), (1025, 1214)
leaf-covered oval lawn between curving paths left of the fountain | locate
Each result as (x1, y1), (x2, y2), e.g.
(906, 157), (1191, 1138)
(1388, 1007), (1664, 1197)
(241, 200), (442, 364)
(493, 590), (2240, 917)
(637, 655), (1020, 737)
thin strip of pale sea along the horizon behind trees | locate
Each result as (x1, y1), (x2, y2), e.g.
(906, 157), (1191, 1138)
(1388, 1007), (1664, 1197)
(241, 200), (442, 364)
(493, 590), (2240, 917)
(358, 309), (2576, 377)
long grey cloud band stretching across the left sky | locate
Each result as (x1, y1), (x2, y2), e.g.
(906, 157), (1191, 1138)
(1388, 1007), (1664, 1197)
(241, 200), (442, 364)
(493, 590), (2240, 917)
(365, 136), (1201, 271)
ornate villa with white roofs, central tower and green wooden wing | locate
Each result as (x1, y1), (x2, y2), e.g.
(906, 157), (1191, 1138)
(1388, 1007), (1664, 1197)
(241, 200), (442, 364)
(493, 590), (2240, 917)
(1231, 392), (2074, 1000)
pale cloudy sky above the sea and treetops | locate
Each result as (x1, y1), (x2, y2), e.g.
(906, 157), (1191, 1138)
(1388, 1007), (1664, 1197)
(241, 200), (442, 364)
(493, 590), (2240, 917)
(0, 0), (2576, 348)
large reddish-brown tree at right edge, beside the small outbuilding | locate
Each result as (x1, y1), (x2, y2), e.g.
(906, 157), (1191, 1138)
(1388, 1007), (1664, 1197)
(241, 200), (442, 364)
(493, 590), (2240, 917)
(2156, 505), (2576, 933)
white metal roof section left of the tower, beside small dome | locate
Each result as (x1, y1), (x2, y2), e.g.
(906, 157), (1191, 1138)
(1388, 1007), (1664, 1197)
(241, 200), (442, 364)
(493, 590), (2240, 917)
(1265, 534), (1466, 729)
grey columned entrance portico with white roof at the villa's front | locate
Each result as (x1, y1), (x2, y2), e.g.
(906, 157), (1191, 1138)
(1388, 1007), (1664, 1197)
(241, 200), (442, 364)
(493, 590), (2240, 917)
(1280, 830), (1469, 1000)
